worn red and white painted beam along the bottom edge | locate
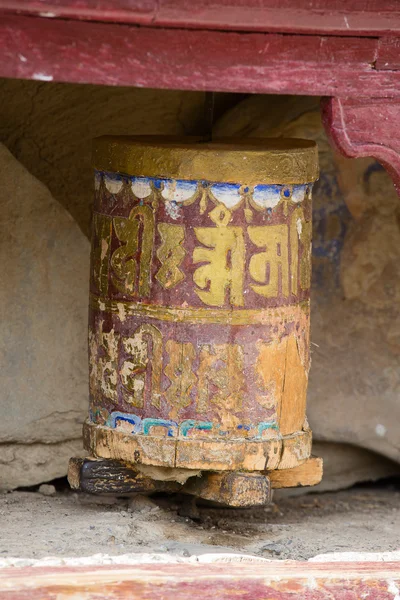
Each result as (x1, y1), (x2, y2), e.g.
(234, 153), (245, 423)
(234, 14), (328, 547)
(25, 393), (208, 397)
(0, 561), (400, 600)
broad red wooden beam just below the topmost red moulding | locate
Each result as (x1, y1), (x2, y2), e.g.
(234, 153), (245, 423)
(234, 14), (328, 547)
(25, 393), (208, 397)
(0, 14), (400, 98)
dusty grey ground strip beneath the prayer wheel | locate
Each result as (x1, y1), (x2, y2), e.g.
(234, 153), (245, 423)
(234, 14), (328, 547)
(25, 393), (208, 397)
(0, 487), (400, 560)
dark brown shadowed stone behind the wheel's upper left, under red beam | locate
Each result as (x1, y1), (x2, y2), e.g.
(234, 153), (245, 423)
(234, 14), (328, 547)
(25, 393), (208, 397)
(0, 79), (204, 236)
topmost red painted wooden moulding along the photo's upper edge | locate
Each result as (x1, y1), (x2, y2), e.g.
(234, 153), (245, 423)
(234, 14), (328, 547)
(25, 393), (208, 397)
(0, 0), (400, 36)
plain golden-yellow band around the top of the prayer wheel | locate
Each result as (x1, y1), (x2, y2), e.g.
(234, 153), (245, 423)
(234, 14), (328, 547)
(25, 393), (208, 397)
(93, 136), (319, 186)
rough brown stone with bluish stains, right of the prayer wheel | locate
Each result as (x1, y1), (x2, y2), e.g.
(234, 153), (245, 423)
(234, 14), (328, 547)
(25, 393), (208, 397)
(216, 96), (400, 472)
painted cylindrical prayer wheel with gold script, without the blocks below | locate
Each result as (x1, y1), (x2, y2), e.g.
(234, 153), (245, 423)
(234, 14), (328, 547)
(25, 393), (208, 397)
(84, 137), (318, 482)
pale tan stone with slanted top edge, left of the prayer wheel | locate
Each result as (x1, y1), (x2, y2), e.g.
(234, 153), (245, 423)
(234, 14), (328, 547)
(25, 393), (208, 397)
(0, 146), (89, 443)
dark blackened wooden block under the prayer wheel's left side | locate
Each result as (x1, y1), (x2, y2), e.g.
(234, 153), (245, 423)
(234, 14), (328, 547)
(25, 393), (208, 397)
(68, 458), (182, 494)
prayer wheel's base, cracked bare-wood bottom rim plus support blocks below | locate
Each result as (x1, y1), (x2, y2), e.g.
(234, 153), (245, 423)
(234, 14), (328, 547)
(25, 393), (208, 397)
(68, 421), (322, 508)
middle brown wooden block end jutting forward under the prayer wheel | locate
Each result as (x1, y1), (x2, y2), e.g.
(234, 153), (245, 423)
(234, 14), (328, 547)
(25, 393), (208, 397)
(182, 472), (271, 508)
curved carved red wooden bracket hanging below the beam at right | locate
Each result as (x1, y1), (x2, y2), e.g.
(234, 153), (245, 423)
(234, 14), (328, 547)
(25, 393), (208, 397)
(321, 95), (400, 195)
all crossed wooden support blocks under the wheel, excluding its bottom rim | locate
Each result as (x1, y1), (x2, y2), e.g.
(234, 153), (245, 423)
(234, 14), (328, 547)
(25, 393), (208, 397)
(68, 457), (322, 508)
